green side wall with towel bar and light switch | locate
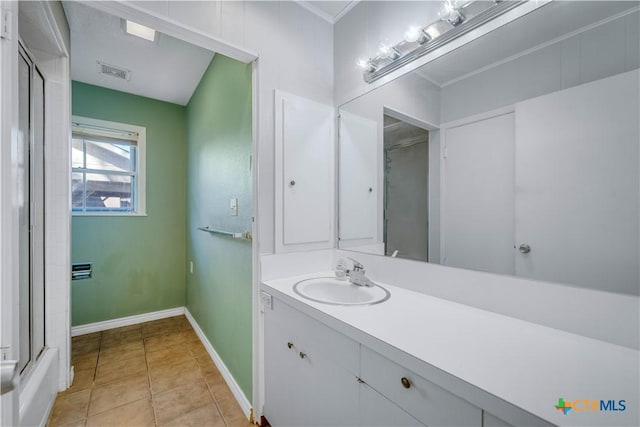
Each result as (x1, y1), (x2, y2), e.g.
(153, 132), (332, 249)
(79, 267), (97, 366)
(187, 55), (252, 400)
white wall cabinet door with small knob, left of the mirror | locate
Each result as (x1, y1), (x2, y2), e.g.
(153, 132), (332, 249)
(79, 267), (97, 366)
(275, 91), (335, 252)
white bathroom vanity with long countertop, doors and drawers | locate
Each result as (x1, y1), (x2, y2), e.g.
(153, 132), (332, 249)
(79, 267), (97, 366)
(262, 272), (638, 426)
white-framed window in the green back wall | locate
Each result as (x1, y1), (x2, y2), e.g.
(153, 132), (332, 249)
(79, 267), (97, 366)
(71, 116), (146, 215)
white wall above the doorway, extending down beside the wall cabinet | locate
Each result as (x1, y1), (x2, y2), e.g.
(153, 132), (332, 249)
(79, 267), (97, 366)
(121, 0), (333, 253)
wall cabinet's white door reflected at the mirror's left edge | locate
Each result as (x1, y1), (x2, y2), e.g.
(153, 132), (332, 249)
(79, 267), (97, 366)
(338, 111), (378, 248)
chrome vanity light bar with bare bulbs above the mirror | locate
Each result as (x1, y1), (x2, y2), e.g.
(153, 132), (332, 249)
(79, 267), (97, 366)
(356, 0), (526, 83)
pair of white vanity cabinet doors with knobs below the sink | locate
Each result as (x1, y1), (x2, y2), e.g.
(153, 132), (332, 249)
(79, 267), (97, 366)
(264, 299), (359, 427)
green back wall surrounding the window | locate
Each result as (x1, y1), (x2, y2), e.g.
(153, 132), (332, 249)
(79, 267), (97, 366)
(71, 82), (187, 326)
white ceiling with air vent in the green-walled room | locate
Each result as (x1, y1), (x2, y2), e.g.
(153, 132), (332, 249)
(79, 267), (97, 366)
(63, 1), (214, 105)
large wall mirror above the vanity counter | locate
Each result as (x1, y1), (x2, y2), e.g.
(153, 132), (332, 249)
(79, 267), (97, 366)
(338, 1), (640, 295)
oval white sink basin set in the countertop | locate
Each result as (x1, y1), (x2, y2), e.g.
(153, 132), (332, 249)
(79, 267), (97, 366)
(293, 277), (391, 305)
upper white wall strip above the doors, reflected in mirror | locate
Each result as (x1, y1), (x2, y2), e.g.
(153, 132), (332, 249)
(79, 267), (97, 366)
(442, 12), (640, 123)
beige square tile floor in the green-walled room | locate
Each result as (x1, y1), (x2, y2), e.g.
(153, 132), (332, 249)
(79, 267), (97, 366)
(47, 316), (251, 427)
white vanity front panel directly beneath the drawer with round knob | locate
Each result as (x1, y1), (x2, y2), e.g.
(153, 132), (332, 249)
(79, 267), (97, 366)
(359, 383), (424, 427)
